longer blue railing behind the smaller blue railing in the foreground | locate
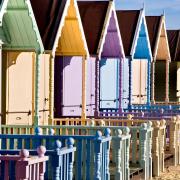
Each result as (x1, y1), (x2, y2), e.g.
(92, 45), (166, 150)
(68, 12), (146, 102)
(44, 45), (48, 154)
(0, 129), (111, 180)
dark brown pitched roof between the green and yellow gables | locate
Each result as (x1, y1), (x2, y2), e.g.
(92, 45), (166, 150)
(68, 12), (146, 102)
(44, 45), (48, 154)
(30, 0), (67, 50)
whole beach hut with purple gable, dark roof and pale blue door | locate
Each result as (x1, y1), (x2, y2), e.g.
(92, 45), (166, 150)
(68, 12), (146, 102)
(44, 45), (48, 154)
(78, 1), (124, 116)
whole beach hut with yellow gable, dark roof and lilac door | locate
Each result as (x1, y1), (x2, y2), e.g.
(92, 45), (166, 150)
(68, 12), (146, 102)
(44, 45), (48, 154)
(31, 0), (89, 124)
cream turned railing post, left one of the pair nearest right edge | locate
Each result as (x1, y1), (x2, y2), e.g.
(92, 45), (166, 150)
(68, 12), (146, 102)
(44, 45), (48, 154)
(169, 117), (178, 166)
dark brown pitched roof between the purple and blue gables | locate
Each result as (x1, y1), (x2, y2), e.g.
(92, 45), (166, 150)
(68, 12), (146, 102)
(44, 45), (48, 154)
(116, 10), (140, 56)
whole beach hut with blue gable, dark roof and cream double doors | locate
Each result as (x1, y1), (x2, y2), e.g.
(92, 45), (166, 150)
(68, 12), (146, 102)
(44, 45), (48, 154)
(116, 9), (152, 109)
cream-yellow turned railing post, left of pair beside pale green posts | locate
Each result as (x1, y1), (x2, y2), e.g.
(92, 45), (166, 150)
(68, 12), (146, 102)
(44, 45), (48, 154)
(152, 121), (160, 176)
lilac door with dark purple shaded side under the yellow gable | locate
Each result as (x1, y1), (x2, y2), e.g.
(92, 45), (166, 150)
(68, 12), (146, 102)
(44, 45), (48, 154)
(54, 57), (82, 118)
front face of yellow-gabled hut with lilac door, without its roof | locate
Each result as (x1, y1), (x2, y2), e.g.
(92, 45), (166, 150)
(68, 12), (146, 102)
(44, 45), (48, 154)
(53, 0), (89, 121)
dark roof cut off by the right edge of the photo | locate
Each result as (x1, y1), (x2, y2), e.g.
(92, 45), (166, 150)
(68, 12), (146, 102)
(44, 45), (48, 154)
(167, 30), (180, 61)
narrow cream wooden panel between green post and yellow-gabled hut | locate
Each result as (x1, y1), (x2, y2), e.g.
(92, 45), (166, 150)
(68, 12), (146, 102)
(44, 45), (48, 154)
(39, 54), (49, 125)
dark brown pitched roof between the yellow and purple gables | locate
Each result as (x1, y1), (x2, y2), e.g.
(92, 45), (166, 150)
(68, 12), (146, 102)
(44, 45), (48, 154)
(78, 1), (109, 55)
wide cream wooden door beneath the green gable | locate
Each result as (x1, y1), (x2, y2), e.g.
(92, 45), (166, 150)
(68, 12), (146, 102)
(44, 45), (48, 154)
(6, 53), (34, 125)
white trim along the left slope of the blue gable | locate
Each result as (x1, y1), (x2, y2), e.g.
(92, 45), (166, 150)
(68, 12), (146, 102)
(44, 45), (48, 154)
(130, 9), (143, 58)
